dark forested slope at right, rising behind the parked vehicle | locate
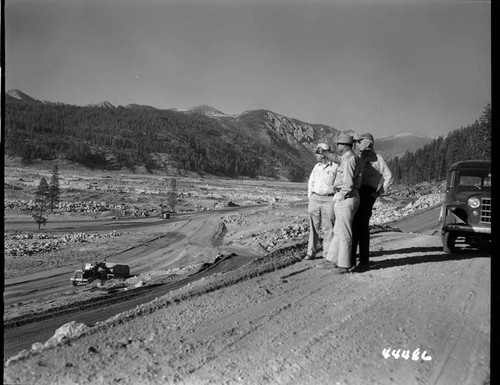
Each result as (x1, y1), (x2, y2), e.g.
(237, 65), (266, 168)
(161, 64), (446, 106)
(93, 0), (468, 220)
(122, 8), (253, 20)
(389, 104), (492, 185)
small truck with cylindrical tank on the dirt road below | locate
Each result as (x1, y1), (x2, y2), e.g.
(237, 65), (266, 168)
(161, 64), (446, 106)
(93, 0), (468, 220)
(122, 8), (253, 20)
(70, 260), (130, 286)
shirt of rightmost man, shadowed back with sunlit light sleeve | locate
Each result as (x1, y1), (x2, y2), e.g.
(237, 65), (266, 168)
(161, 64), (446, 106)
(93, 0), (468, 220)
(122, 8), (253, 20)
(361, 151), (393, 195)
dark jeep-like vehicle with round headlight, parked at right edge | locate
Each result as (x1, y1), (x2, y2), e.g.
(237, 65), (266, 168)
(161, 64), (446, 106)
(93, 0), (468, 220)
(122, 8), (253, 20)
(439, 160), (491, 254)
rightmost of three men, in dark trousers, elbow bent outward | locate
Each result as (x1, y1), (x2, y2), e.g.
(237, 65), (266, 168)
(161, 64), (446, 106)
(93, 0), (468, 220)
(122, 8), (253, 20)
(351, 133), (393, 269)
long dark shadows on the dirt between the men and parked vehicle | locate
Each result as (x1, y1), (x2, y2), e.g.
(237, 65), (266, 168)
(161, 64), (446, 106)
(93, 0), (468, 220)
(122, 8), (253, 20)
(367, 247), (491, 271)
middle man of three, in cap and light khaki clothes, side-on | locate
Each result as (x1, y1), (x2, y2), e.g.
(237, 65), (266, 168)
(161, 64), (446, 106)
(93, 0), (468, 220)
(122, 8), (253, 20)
(317, 133), (361, 274)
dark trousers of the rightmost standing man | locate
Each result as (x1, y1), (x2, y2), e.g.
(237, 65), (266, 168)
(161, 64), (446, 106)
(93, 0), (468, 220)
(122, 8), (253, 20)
(351, 186), (377, 266)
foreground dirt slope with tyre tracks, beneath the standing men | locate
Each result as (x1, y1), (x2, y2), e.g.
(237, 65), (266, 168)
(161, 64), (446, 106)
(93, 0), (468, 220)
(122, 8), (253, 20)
(4, 232), (491, 384)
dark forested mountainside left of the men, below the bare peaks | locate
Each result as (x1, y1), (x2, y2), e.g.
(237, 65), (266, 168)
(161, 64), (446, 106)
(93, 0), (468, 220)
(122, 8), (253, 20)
(5, 102), (311, 181)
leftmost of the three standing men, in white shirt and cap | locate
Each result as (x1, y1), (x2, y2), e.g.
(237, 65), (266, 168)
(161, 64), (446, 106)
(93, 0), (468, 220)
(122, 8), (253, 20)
(304, 143), (338, 260)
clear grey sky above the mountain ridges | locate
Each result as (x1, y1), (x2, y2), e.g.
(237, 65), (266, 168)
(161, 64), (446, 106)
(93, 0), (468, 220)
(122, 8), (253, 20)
(4, 0), (491, 138)
